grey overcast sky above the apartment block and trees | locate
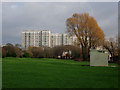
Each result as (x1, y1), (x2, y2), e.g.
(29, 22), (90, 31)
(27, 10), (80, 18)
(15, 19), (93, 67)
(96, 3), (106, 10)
(2, 2), (118, 44)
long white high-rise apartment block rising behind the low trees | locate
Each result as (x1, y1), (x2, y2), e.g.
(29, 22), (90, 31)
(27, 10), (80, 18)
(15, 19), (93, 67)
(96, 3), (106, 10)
(22, 30), (77, 49)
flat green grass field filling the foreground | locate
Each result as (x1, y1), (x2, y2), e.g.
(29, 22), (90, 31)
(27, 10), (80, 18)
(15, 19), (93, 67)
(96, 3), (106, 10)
(2, 58), (118, 88)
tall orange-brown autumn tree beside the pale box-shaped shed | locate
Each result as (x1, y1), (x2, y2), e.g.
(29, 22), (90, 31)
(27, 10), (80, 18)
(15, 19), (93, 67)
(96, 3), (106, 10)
(66, 13), (104, 60)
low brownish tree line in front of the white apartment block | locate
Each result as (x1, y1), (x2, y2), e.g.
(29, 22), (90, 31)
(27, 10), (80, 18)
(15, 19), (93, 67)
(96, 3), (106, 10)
(2, 43), (82, 59)
